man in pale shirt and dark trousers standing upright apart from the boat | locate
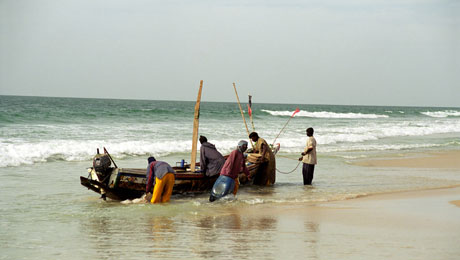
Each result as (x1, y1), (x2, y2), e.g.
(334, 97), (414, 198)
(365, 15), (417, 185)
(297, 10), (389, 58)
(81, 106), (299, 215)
(299, 127), (317, 185)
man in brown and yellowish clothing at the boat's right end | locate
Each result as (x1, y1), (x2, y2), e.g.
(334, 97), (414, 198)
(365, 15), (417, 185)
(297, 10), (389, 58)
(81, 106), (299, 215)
(249, 132), (276, 185)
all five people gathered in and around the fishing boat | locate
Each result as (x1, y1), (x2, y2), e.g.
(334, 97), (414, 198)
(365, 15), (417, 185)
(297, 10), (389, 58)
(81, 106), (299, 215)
(146, 127), (317, 203)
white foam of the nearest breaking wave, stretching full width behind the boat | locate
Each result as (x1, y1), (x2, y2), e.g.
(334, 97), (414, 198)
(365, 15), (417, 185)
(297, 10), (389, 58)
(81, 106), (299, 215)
(0, 120), (460, 167)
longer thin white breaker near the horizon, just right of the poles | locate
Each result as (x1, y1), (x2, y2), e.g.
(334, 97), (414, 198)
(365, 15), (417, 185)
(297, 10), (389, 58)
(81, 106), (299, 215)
(262, 109), (389, 119)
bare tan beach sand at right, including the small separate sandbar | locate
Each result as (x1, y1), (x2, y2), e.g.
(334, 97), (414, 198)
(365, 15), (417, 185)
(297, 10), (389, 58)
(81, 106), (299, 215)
(219, 151), (460, 259)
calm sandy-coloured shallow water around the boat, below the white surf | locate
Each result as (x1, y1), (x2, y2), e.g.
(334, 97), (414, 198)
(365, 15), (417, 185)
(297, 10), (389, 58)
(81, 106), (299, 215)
(0, 153), (460, 259)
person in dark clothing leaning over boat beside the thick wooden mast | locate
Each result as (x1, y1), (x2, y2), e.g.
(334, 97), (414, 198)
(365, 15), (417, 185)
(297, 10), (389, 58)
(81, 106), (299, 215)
(200, 135), (225, 177)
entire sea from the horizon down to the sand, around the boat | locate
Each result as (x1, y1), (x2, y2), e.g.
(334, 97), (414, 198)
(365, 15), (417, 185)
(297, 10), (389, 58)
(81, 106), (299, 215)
(0, 96), (460, 259)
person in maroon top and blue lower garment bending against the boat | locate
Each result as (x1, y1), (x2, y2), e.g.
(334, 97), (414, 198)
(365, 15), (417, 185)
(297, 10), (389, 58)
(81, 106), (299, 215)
(209, 140), (250, 202)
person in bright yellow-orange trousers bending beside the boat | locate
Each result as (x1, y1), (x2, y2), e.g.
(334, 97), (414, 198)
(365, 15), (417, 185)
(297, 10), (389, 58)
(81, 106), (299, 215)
(145, 157), (176, 204)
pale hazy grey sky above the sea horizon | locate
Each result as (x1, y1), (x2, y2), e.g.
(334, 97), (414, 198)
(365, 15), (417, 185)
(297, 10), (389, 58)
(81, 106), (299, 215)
(0, 0), (460, 107)
